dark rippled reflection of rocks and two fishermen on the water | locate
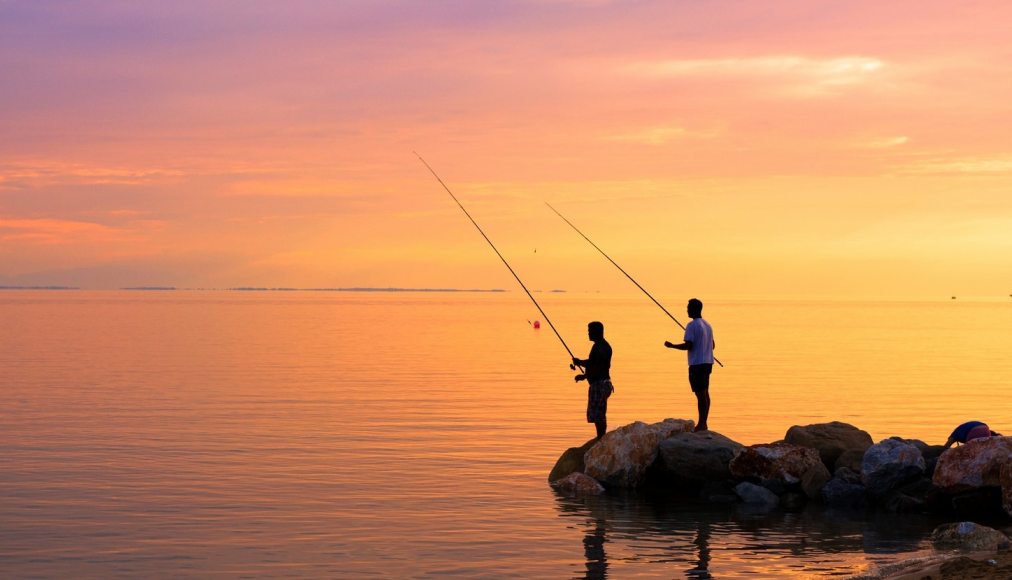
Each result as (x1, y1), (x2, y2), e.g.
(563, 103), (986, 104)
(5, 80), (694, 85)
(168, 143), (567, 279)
(556, 493), (938, 579)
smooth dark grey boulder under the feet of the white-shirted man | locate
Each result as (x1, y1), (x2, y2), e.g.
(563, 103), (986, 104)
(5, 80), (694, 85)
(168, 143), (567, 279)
(658, 431), (744, 485)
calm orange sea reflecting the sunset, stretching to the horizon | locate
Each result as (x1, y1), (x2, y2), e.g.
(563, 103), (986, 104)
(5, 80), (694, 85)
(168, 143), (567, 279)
(0, 291), (1012, 578)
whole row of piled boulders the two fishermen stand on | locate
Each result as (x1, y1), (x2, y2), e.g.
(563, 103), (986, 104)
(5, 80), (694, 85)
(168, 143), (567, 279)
(549, 419), (1012, 518)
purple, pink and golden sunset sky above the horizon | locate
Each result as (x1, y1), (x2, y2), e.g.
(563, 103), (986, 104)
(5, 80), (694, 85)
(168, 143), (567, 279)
(0, 0), (1012, 300)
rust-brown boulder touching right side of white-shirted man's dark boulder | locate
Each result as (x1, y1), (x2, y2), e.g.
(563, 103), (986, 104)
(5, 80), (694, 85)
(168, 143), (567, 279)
(729, 441), (830, 497)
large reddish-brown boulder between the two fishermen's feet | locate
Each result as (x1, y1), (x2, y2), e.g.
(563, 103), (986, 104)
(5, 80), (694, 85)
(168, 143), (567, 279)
(584, 419), (694, 488)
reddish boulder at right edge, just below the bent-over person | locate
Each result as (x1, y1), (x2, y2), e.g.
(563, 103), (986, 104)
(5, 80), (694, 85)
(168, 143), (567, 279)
(932, 437), (1012, 492)
